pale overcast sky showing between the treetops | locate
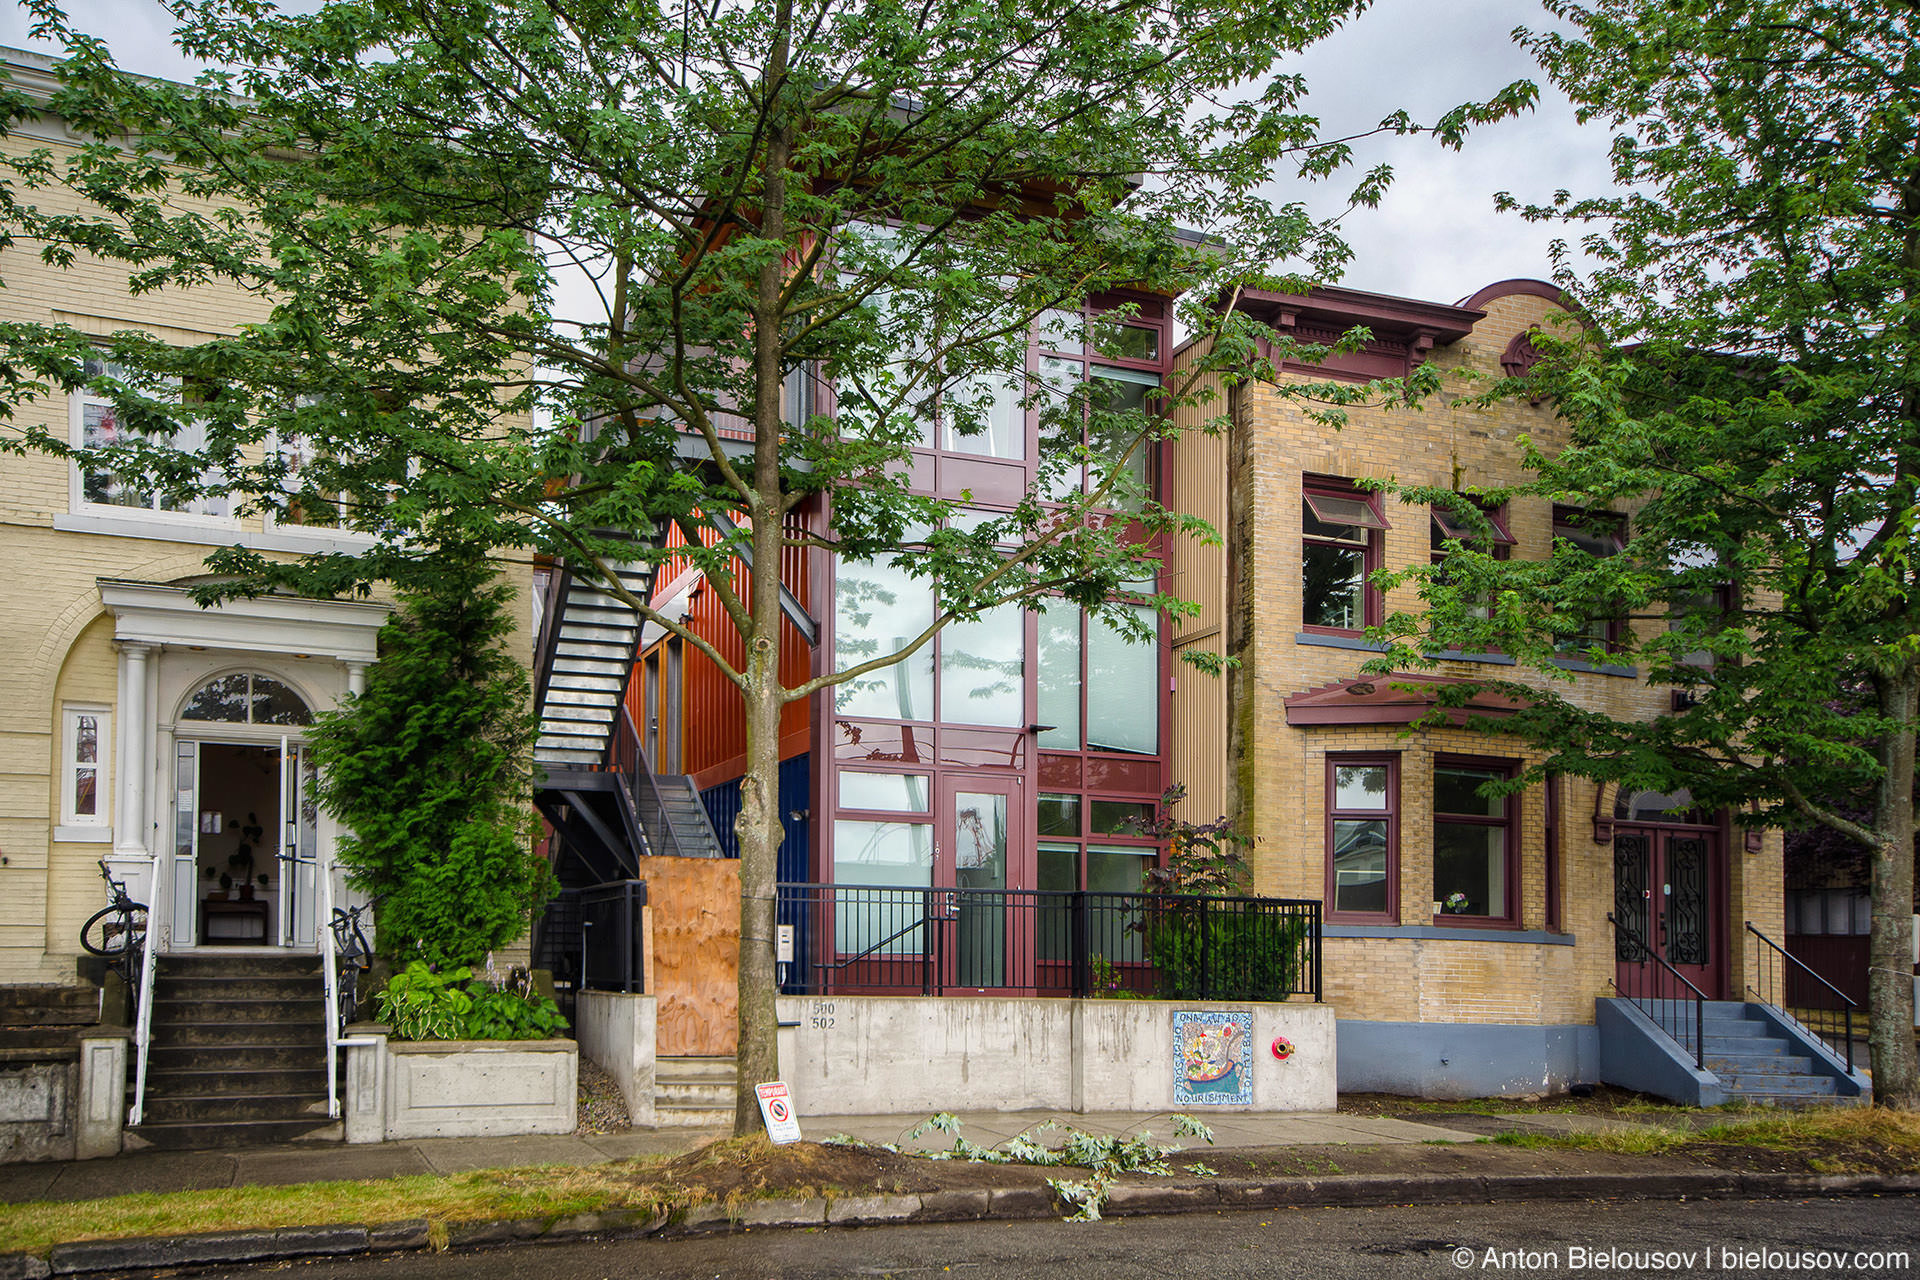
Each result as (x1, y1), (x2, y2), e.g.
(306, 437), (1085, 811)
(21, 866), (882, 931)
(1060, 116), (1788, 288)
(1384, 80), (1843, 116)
(0, 0), (1607, 301)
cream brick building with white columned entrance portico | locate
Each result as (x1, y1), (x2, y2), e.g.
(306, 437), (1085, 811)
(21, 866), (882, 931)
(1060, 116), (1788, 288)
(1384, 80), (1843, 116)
(0, 50), (530, 984)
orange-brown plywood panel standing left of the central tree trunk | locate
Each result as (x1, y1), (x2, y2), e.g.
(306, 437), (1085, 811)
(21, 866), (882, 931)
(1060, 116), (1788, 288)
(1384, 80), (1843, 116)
(641, 858), (739, 1057)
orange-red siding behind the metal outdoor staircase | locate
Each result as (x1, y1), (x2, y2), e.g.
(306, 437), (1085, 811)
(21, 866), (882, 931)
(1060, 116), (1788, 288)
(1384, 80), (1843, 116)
(626, 514), (812, 789)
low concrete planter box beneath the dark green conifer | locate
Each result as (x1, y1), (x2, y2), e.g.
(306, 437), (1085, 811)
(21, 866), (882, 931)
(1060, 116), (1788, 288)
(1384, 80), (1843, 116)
(346, 1025), (580, 1142)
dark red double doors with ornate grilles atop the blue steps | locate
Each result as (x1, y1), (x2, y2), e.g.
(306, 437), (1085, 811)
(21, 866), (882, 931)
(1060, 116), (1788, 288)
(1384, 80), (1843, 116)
(1613, 791), (1728, 1000)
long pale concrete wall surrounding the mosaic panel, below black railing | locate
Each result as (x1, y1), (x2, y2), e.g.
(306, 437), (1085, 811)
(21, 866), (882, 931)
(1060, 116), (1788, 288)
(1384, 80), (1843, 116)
(780, 996), (1334, 1115)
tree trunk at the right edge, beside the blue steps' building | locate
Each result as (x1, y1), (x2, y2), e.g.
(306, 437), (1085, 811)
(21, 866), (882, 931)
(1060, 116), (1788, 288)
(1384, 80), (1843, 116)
(1866, 664), (1920, 1111)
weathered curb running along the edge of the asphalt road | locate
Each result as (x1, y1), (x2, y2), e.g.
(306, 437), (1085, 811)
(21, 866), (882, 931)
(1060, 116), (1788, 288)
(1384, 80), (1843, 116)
(0, 1169), (1920, 1280)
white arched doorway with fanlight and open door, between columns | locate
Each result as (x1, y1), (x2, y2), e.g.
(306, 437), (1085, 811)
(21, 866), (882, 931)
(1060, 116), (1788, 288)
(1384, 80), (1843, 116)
(173, 670), (319, 946)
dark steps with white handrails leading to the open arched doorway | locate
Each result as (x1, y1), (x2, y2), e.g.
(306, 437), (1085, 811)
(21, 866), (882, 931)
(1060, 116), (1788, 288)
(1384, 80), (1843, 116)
(129, 954), (344, 1151)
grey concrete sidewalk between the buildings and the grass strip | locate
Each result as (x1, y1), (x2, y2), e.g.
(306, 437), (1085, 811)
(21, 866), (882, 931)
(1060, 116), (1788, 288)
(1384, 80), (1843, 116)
(0, 1111), (1636, 1203)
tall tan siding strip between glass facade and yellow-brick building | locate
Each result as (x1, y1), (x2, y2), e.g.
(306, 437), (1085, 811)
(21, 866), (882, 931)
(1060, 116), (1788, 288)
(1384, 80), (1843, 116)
(1167, 335), (1227, 821)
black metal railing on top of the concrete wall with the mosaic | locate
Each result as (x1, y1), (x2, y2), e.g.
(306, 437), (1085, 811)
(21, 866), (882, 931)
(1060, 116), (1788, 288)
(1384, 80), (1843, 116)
(778, 885), (1321, 1000)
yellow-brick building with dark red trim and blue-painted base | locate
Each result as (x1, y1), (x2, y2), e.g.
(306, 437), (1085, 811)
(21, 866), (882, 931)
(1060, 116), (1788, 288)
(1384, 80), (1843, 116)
(1169, 280), (1782, 1096)
